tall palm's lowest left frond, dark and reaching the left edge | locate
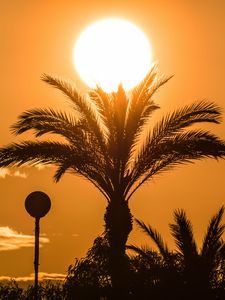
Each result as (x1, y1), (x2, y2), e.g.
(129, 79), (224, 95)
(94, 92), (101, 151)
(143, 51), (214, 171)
(0, 141), (112, 199)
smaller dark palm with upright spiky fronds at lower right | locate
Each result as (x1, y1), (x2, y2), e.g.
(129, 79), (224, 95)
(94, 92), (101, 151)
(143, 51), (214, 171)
(127, 206), (225, 299)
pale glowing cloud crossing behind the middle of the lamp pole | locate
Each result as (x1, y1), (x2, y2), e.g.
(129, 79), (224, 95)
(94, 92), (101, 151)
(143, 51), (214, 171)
(0, 226), (49, 251)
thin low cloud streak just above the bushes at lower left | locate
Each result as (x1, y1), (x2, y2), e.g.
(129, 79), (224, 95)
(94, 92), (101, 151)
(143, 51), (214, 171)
(0, 272), (66, 281)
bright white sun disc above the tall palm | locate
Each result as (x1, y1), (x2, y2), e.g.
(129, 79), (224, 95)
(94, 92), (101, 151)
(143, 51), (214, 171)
(73, 18), (152, 92)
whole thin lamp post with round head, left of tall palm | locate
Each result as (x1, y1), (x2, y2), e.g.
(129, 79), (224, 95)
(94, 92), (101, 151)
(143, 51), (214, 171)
(25, 191), (51, 299)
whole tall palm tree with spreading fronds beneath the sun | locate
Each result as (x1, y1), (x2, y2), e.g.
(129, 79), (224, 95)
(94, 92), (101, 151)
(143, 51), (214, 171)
(0, 69), (225, 299)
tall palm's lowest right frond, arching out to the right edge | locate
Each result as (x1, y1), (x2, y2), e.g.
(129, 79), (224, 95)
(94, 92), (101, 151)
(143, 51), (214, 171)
(126, 130), (225, 199)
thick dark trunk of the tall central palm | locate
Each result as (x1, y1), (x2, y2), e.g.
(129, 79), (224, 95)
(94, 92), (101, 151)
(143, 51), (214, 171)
(104, 197), (132, 300)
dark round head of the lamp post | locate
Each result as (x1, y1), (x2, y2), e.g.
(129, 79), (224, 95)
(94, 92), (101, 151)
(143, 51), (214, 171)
(25, 191), (51, 218)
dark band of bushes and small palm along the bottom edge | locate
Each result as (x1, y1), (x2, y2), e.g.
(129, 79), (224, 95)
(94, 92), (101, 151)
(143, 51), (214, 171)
(0, 207), (225, 300)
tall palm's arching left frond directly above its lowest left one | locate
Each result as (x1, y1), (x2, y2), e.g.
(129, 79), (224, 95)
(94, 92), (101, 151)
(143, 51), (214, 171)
(12, 109), (112, 175)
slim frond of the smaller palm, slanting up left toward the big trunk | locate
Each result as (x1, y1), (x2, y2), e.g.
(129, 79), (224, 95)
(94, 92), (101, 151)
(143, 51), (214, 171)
(135, 219), (169, 259)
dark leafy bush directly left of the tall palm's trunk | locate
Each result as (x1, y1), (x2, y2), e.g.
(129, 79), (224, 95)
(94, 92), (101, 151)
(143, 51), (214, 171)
(65, 237), (112, 300)
